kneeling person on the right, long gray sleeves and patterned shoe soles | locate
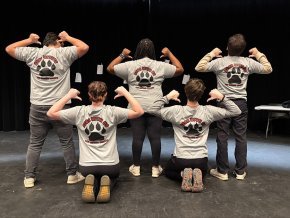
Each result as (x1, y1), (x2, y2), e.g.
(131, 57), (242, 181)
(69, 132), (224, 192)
(149, 79), (241, 192)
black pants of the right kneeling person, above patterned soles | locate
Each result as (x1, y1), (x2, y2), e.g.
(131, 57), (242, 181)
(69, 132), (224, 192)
(164, 155), (208, 181)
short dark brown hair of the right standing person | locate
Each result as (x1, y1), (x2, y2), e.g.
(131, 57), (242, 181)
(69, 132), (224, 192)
(228, 34), (247, 56)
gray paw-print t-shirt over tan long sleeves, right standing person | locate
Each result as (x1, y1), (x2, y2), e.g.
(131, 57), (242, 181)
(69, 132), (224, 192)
(207, 56), (265, 100)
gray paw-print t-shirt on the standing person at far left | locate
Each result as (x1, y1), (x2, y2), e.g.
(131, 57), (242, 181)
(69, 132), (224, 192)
(15, 46), (78, 105)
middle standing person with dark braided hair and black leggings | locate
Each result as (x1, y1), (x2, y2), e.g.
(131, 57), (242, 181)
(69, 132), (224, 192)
(107, 38), (184, 177)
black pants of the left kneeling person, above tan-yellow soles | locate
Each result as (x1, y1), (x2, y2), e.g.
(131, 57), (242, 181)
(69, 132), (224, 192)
(79, 164), (120, 193)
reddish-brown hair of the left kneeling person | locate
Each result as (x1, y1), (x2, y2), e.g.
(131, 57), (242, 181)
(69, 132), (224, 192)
(88, 81), (107, 102)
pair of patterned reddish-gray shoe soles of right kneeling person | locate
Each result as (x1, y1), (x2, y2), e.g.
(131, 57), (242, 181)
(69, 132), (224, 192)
(181, 168), (203, 193)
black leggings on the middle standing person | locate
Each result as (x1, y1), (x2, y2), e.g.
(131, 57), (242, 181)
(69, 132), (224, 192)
(130, 113), (162, 166)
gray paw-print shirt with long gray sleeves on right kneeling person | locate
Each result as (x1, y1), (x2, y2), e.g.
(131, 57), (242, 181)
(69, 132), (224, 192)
(149, 97), (241, 159)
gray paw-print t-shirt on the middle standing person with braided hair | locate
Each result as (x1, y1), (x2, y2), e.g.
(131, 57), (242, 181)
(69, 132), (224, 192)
(114, 58), (176, 112)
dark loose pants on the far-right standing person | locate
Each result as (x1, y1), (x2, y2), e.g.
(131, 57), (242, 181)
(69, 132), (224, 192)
(216, 99), (248, 174)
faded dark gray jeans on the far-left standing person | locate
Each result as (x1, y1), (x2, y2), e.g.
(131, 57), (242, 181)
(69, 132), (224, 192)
(24, 104), (78, 178)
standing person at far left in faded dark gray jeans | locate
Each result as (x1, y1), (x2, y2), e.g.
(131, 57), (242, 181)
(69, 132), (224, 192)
(6, 31), (89, 188)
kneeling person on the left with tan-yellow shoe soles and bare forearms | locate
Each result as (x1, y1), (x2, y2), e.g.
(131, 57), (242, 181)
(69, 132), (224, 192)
(47, 81), (144, 203)
